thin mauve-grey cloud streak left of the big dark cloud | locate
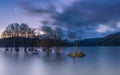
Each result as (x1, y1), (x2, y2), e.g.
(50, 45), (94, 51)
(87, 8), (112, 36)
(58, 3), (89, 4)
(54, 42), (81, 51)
(21, 1), (55, 14)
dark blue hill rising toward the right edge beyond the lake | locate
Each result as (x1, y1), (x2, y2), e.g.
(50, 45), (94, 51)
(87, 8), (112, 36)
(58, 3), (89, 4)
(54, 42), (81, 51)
(78, 32), (120, 46)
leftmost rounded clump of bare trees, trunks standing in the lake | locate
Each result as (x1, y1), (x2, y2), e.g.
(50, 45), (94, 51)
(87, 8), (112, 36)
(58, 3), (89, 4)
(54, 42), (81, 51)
(2, 23), (34, 51)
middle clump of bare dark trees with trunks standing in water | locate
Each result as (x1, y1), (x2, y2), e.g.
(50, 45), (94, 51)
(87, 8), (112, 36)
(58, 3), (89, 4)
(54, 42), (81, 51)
(42, 26), (64, 55)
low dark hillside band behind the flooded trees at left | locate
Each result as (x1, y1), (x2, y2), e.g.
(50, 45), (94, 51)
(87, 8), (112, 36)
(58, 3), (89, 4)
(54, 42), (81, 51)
(0, 37), (68, 47)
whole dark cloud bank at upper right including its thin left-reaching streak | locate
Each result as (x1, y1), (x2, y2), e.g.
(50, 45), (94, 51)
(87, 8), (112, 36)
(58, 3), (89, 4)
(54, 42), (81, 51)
(20, 0), (120, 37)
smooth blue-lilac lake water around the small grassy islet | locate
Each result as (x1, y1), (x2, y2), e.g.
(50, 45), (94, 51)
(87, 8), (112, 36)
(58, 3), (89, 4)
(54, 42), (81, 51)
(0, 47), (120, 75)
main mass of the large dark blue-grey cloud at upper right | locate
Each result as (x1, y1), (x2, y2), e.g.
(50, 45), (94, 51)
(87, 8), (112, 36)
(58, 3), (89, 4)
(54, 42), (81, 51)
(54, 0), (120, 27)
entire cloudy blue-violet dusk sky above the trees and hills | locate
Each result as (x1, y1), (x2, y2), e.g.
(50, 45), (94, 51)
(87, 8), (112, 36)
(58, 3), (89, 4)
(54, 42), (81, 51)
(0, 0), (120, 38)
